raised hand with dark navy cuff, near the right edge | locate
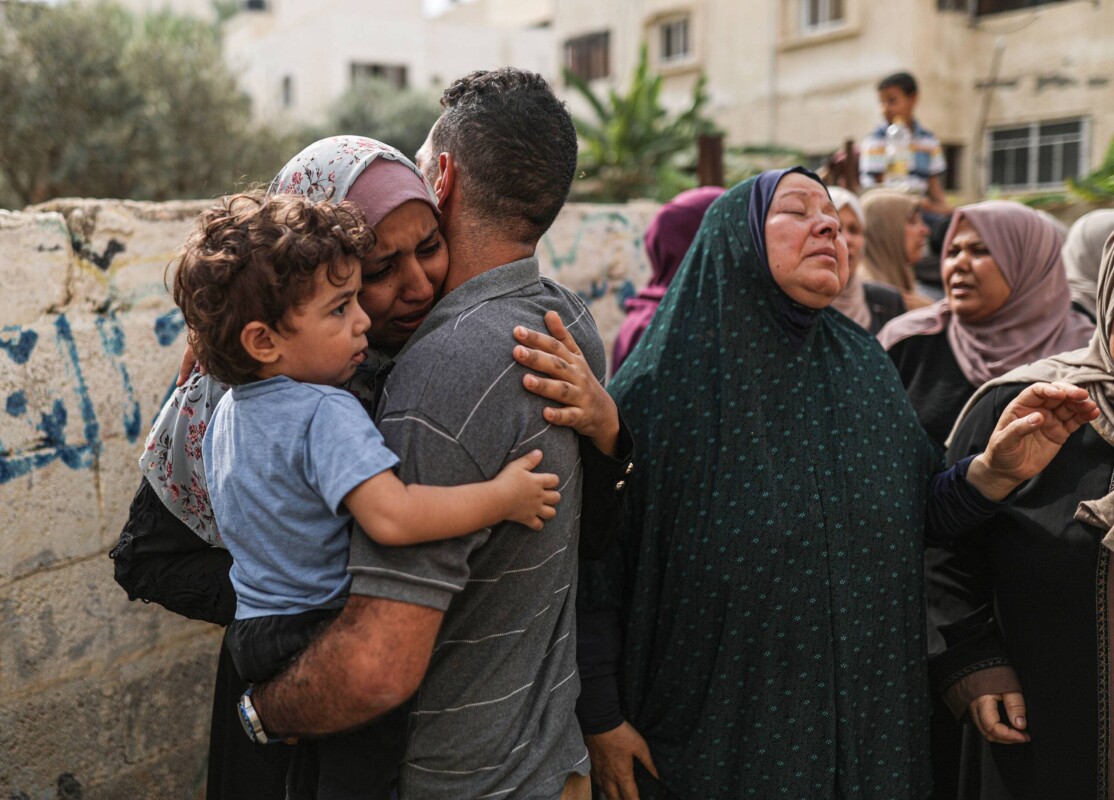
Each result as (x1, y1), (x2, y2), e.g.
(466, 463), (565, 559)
(967, 382), (1098, 501)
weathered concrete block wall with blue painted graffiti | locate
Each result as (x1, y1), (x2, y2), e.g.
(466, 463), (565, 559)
(0, 199), (656, 800)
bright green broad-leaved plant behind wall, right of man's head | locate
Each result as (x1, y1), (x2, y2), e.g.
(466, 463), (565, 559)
(565, 46), (716, 202)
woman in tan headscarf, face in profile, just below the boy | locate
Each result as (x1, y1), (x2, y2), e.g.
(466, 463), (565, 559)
(862, 189), (932, 311)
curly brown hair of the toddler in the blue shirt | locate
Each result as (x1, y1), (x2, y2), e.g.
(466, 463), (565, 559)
(167, 193), (375, 384)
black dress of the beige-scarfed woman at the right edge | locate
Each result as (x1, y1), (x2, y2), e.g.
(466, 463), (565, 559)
(928, 383), (1114, 800)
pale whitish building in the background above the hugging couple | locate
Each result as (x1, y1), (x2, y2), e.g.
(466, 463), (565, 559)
(224, 0), (557, 124)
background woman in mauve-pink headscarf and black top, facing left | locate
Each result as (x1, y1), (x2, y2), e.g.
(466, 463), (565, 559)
(878, 201), (1094, 445)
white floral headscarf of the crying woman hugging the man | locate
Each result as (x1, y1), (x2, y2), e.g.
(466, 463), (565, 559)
(139, 136), (430, 547)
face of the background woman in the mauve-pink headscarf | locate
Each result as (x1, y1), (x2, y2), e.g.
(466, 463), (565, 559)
(940, 218), (1009, 322)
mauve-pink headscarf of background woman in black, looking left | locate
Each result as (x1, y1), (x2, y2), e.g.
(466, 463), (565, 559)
(878, 201), (1094, 387)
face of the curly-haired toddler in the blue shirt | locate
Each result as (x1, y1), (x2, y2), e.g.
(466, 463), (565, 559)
(271, 258), (371, 386)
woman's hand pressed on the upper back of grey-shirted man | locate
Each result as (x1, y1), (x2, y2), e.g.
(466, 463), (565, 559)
(515, 311), (619, 456)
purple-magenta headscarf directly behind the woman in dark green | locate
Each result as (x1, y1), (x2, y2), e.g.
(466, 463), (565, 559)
(612, 186), (723, 374)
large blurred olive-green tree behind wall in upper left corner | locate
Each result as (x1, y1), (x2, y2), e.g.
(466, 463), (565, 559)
(0, 2), (293, 204)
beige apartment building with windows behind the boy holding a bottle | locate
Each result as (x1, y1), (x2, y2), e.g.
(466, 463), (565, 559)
(553, 0), (1114, 197)
